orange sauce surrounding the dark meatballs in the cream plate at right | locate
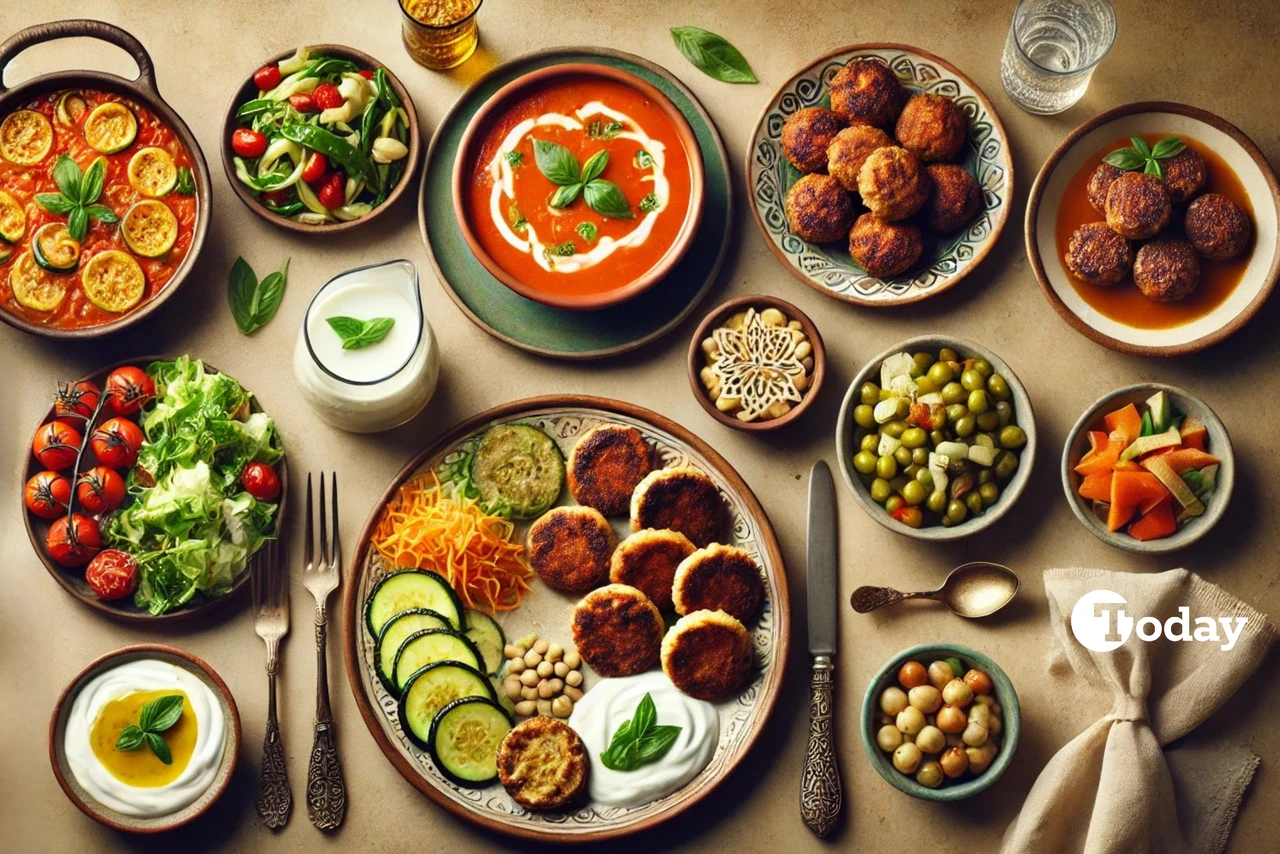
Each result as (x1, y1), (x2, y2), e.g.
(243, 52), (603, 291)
(1055, 133), (1253, 329)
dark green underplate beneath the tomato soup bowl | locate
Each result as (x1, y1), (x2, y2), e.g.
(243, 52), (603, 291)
(417, 47), (732, 359)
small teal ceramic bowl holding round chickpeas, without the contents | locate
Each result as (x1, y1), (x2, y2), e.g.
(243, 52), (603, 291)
(863, 643), (1023, 802)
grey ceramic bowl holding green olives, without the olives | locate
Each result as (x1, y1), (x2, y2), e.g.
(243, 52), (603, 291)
(836, 335), (1036, 542)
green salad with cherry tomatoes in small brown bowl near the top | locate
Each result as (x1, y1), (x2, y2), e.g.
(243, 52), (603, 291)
(227, 47), (410, 225)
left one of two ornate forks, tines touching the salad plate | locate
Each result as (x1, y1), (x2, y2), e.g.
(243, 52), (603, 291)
(250, 539), (293, 830)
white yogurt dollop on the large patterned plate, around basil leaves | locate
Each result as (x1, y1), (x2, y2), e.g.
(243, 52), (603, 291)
(568, 670), (719, 807)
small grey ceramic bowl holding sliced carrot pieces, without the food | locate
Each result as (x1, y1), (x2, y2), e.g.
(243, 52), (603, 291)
(1062, 383), (1235, 554)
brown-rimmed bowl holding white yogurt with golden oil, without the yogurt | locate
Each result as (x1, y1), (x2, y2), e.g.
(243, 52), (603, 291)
(49, 644), (241, 834)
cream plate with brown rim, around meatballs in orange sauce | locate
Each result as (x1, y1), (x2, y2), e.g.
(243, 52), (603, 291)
(1025, 101), (1280, 356)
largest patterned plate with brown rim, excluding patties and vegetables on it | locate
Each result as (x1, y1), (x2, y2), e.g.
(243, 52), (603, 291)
(343, 396), (790, 842)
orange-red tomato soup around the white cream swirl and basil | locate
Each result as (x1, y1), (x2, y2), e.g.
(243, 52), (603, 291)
(465, 76), (692, 302)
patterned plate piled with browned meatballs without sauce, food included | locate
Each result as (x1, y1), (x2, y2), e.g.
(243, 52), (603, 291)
(746, 44), (1014, 306)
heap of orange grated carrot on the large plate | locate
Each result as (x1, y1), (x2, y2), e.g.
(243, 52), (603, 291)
(372, 472), (532, 613)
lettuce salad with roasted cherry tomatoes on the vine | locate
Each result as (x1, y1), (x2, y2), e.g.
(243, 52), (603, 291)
(23, 356), (284, 615)
